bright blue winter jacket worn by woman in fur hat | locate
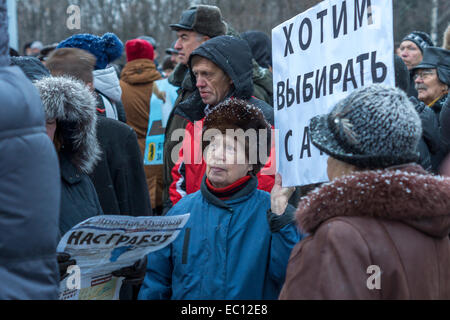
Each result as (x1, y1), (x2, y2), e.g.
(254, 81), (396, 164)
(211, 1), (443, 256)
(139, 177), (300, 300)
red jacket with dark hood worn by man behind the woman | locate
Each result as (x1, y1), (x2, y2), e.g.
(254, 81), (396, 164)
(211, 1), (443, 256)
(166, 36), (274, 206)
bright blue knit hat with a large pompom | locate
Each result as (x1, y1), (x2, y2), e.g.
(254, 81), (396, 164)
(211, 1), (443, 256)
(57, 32), (124, 70)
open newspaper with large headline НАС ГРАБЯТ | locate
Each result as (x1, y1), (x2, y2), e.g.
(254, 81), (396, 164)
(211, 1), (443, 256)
(57, 214), (190, 300)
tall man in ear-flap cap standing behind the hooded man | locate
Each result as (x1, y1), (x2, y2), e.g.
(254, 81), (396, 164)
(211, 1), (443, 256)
(163, 5), (227, 211)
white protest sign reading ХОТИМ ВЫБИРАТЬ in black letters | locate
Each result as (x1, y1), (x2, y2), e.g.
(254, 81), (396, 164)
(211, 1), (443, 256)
(272, 0), (395, 186)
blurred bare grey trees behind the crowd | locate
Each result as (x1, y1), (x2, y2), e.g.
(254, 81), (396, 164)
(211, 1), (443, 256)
(17, 0), (450, 55)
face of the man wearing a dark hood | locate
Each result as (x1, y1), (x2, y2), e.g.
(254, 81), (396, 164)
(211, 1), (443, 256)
(192, 56), (233, 106)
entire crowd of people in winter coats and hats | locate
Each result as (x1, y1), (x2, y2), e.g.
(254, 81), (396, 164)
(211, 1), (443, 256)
(0, 0), (450, 300)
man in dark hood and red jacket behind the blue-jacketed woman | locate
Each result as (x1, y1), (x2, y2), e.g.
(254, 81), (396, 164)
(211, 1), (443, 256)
(166, 36), (275, 209)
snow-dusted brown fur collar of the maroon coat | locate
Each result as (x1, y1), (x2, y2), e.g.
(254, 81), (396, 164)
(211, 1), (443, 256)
(296, 164), (450, 238)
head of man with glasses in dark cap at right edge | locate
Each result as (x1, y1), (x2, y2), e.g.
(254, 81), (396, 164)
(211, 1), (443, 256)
(411, 47), (450, 115)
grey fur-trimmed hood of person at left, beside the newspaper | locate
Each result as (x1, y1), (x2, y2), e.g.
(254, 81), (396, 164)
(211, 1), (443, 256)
(34, 77), (101, 174)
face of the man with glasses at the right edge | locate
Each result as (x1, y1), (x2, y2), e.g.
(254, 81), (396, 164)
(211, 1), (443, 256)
(414, 69), (448, 105)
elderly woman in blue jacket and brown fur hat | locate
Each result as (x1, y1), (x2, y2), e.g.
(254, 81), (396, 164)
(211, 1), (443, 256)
(139, 98), (300, 300)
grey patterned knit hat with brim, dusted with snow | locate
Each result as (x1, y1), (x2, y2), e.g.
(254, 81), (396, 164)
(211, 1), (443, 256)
(310, 84), (422, 169)
